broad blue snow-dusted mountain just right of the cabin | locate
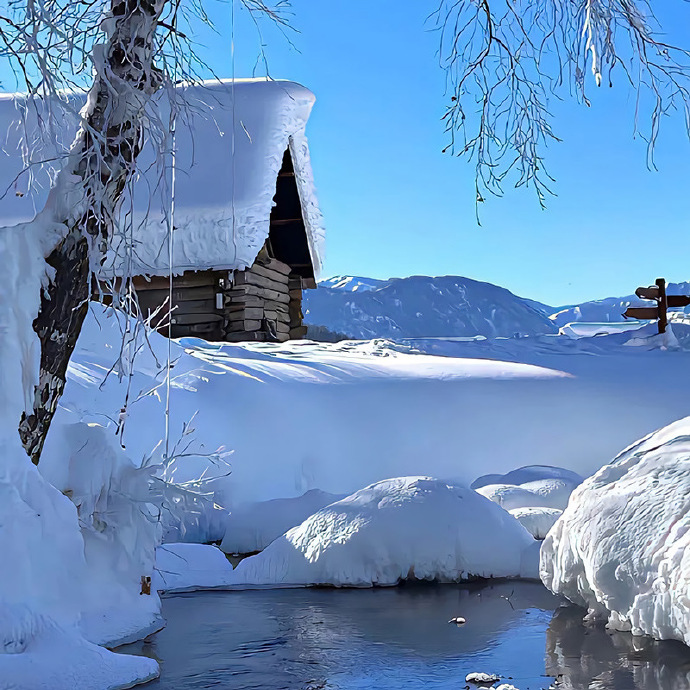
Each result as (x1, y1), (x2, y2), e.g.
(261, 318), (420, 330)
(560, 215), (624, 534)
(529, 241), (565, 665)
(304, 276), (557, 339)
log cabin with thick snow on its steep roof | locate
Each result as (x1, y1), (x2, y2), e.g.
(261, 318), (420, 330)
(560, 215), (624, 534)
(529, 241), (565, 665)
(0, 79), (324, 341)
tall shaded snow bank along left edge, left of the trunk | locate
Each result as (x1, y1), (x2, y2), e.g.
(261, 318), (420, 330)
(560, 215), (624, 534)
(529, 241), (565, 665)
(0, 224), (157, 690)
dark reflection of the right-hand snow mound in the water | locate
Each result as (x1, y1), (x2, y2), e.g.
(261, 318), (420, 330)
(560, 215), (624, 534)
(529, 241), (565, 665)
(546, 607), (690, 690)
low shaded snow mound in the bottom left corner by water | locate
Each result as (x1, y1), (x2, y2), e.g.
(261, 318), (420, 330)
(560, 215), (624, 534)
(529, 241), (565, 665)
(0, 606), (158, 690)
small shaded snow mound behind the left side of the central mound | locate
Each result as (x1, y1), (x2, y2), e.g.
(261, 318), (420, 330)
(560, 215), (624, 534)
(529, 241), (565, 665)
(220, 489), (344, 553)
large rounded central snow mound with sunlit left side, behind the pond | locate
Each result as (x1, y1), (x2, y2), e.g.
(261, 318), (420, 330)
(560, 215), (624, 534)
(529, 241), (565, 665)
(228, 477), (537, 587)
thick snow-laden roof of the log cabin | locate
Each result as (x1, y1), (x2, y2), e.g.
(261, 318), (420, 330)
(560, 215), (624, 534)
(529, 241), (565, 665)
(0, 79), (324, 277)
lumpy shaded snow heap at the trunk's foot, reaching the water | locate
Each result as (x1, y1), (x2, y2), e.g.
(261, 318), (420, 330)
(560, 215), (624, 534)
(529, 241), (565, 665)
(39, 423), (163, 646)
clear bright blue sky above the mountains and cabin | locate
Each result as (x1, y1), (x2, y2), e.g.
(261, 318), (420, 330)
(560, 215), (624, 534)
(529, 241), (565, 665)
(194, 0), (690, 304)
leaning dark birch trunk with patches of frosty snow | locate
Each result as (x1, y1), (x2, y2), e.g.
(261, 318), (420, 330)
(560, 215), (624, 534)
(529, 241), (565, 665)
(19, 0), (166, 464)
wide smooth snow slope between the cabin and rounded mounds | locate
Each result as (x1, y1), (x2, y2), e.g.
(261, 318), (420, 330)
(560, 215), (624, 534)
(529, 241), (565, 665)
(46, 311), (690, 520)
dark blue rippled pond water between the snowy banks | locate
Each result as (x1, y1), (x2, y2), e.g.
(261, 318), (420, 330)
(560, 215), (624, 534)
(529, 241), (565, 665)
(122, 582), (690, 690)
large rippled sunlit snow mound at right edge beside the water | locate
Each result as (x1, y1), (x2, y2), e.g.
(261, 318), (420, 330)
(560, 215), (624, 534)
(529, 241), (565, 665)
(541, 417), (690, 644)
